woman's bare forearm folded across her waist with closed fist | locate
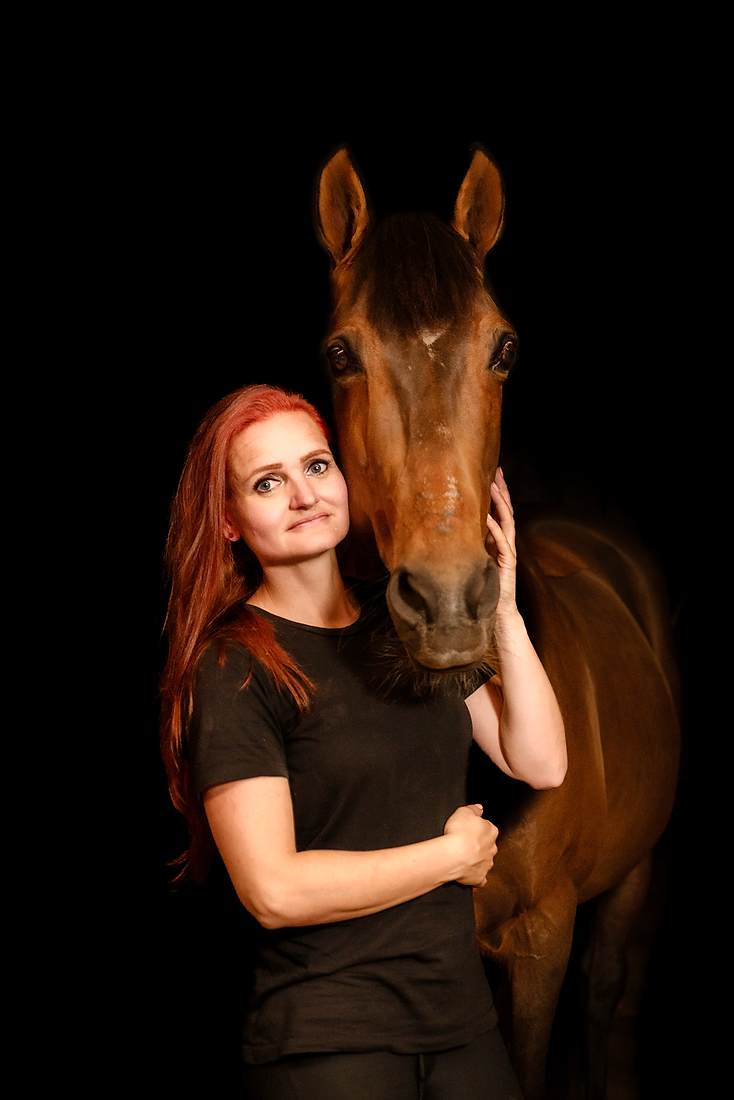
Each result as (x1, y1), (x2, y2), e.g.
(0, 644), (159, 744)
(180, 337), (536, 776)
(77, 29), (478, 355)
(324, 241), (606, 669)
(204, 776), (497, 928)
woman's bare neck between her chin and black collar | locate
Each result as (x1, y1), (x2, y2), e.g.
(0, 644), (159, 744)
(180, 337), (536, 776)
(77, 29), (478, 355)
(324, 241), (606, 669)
(248, 554), (360, 628)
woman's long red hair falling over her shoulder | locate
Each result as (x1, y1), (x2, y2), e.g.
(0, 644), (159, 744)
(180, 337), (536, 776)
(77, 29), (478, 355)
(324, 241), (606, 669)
(161, 386), (329, 882)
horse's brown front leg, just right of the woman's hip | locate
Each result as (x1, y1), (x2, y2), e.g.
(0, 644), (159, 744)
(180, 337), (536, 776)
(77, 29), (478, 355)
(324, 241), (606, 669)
(483, 880), (577, 1100)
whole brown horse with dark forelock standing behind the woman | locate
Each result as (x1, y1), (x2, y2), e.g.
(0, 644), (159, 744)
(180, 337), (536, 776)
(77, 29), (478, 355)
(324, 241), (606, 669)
(317, 146), (679, 1100)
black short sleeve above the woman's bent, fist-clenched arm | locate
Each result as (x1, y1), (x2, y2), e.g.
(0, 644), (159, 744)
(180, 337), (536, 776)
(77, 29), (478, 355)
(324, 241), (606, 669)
(186, 644), (296, 796)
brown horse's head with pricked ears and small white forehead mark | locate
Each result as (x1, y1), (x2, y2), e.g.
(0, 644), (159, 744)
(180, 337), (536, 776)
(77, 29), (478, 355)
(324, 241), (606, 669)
(318, 149), (517, 670)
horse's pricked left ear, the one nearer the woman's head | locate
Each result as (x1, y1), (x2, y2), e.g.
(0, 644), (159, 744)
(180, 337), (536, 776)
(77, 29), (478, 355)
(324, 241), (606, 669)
(316, 149), (370, 264)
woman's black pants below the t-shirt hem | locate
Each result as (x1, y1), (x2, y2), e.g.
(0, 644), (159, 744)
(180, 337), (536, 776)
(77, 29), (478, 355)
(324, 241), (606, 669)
(244, 1027), (522, 1100)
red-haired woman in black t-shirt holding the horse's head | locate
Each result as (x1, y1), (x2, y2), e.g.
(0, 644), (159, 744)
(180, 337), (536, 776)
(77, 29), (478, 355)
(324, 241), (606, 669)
(163, 386), (566, 1100)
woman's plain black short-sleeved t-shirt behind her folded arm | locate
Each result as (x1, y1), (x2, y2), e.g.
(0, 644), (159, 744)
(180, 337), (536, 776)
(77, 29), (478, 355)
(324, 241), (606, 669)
(187, 611), (496, 1064)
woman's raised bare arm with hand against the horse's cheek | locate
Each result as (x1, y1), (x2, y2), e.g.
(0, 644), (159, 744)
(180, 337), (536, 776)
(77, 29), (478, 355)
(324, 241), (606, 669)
(467, 470), (567, 790)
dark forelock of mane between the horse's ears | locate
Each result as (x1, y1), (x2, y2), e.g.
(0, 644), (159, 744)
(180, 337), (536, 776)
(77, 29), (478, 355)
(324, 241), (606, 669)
(353, 213), (483, 334)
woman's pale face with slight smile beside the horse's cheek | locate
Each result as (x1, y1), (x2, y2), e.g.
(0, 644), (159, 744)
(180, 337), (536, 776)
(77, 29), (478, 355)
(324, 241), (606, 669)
(224, 413), (349, 570)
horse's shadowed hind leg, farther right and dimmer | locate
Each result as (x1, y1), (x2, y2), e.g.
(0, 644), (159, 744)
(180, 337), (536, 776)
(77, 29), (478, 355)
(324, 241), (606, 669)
(582, 855), (651, 1100)
